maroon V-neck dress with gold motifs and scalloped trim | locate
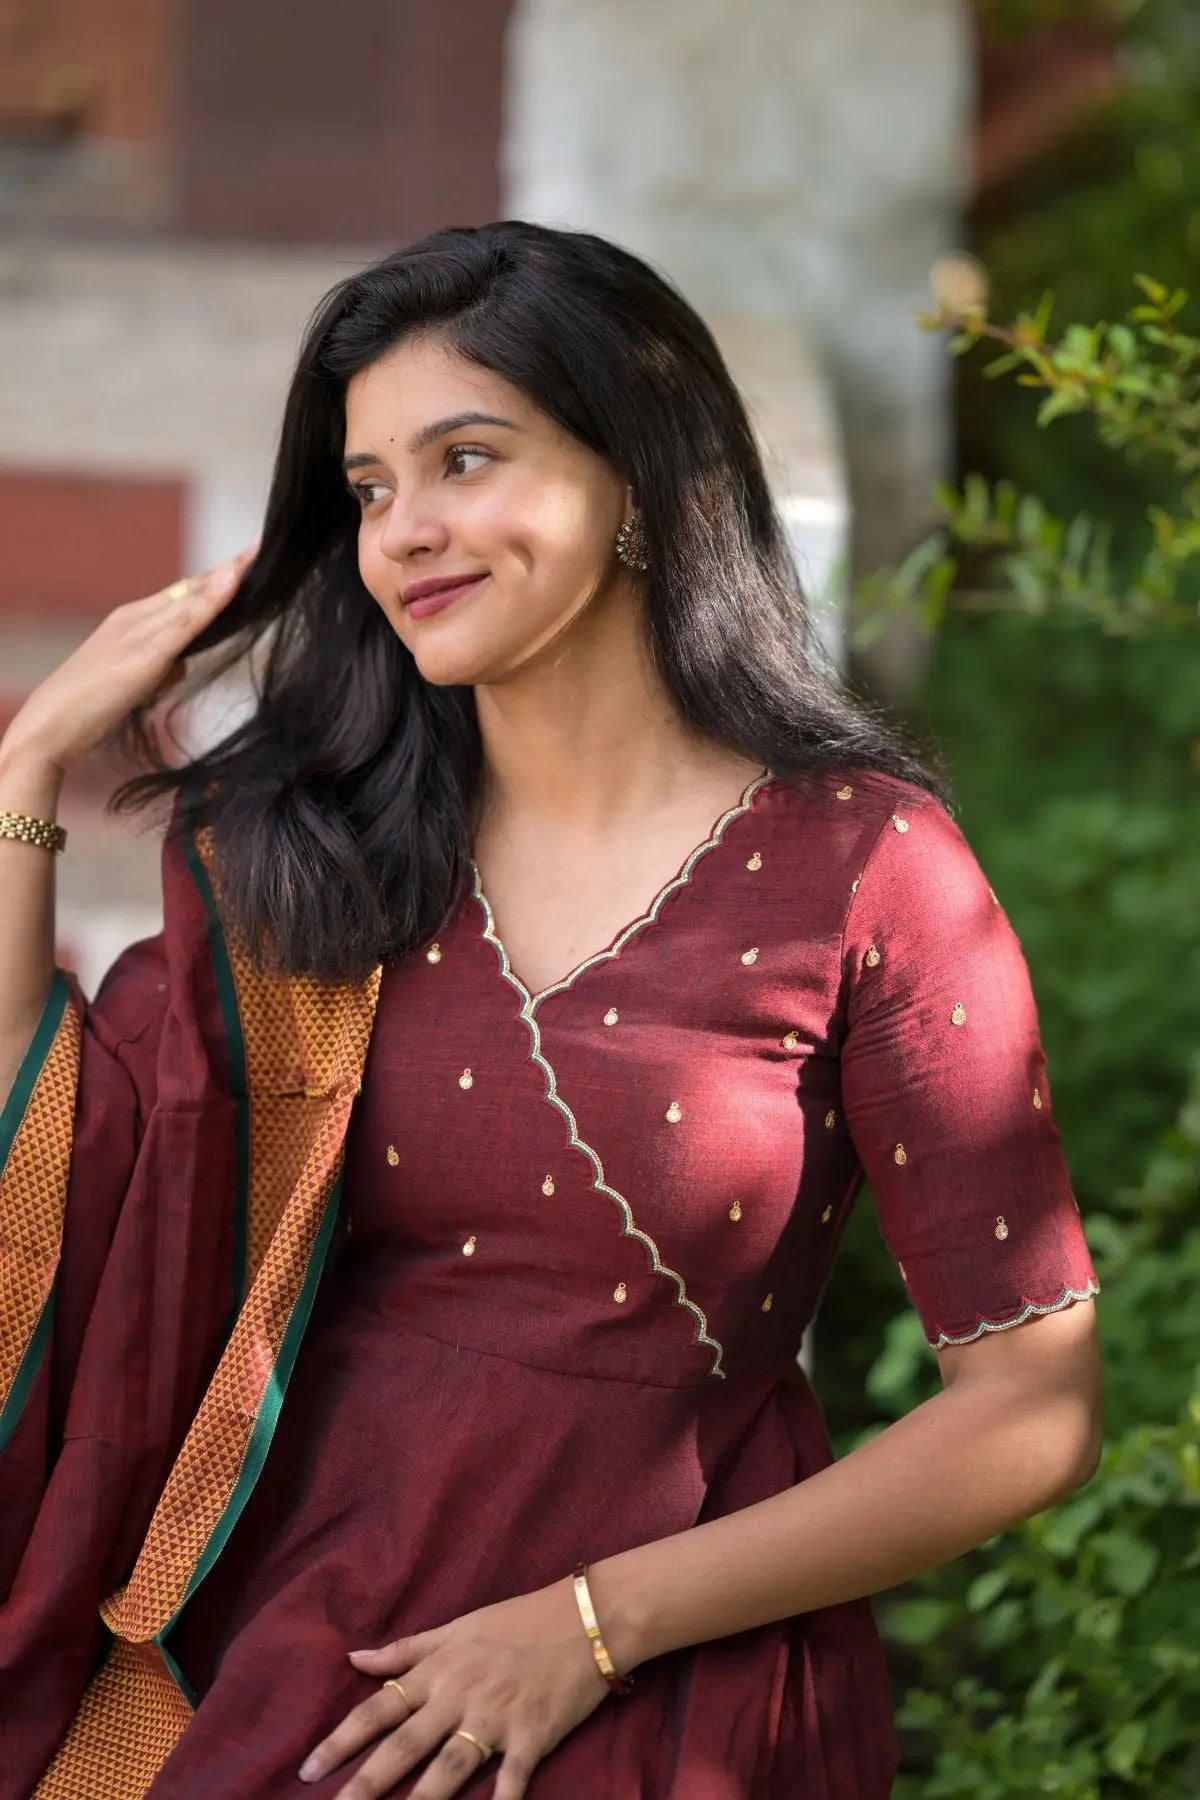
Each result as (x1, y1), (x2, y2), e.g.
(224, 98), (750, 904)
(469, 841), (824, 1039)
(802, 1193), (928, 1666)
(151, 774), (1096, 1800)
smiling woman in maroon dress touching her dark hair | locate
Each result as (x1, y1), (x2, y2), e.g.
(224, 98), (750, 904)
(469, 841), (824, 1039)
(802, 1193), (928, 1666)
(0, 221), (1101, 1800)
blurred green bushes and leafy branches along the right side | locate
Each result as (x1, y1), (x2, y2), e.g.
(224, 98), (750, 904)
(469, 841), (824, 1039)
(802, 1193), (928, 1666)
(834, 179), (1200, 1800)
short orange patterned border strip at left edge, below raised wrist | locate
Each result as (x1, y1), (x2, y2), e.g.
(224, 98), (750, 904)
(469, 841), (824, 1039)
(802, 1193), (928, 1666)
(0, 985), (83, 1406)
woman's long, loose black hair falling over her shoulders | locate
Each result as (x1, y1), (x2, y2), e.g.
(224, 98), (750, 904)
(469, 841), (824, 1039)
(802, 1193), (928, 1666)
(112, 220), (946, 981)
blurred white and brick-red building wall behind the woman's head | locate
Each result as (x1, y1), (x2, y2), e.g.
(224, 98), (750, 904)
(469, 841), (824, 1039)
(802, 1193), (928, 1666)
(0, 0), (973, 986)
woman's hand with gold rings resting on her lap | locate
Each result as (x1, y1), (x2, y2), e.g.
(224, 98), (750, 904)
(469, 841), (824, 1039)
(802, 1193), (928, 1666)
(300, 1577), (608, 1800)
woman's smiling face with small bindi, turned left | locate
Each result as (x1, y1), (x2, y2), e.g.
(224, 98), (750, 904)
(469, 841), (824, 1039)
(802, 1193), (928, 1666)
(345, 337), (631, 686)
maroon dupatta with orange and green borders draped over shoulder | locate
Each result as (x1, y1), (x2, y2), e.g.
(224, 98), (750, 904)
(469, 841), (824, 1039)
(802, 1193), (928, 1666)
(0, 806), (381, 1800)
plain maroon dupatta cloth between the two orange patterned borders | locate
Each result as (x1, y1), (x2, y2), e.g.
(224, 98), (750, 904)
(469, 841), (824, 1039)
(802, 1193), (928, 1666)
(0, 837), (236, 1800)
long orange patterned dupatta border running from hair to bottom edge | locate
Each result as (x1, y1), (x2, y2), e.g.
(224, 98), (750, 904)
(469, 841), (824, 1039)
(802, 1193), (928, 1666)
(38, 833), (381, 1800)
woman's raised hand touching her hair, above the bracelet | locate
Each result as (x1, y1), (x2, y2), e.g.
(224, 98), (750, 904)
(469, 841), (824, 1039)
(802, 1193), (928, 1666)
(4, 544), (257, 772)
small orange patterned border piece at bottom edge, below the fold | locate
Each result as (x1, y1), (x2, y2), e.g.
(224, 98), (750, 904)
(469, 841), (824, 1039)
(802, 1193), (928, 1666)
(34, 1640), (193, 1800)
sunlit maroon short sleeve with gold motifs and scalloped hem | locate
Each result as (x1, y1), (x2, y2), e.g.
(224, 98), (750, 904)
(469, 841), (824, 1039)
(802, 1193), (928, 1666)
(842, 794), (1099, 1348)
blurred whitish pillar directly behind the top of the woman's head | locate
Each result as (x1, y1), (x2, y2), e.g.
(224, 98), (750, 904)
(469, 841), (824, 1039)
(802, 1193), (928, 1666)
(502, 0), (970, 684)
